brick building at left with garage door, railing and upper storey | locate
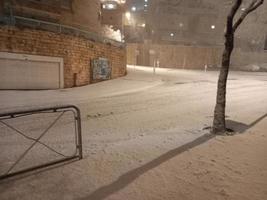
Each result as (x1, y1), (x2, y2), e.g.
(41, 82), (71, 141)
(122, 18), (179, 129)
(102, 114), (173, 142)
(0, 0), (126, 89)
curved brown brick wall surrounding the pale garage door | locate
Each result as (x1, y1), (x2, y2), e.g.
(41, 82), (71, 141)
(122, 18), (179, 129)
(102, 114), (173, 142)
(0, 26), (126, 88)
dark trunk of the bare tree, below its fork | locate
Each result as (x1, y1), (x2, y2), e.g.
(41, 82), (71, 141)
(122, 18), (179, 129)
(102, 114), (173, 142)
(212, 32), (234, 134)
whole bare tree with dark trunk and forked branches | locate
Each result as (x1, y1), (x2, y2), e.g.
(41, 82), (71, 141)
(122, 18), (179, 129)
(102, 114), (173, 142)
(212, 0), (264, 134)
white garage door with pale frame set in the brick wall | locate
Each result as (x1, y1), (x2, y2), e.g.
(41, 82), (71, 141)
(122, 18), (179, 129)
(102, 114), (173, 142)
(0, 52), (64, 89)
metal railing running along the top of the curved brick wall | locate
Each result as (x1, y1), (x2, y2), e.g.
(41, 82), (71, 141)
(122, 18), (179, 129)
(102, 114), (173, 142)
(0, 15), (125, 47)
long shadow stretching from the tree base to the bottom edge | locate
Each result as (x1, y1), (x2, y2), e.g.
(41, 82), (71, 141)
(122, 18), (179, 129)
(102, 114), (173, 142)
(80, 134), (215, 200)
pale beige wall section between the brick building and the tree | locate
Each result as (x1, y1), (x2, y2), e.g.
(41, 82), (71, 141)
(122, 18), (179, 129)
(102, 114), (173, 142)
(127, 44), (222, 69)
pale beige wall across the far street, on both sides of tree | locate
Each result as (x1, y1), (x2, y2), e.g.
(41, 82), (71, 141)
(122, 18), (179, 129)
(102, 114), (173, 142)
(127, 43), (267, 70)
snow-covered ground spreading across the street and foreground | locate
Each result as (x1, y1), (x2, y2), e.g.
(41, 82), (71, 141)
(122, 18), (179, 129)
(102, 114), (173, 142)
(0, 66), (267, 200)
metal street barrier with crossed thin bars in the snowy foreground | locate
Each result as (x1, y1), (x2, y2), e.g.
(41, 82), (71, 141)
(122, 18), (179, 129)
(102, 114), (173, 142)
(0, 105), (83, 179)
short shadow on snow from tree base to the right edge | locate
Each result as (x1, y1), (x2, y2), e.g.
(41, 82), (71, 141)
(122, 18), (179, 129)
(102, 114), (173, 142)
(226, 113), (267, 133)
